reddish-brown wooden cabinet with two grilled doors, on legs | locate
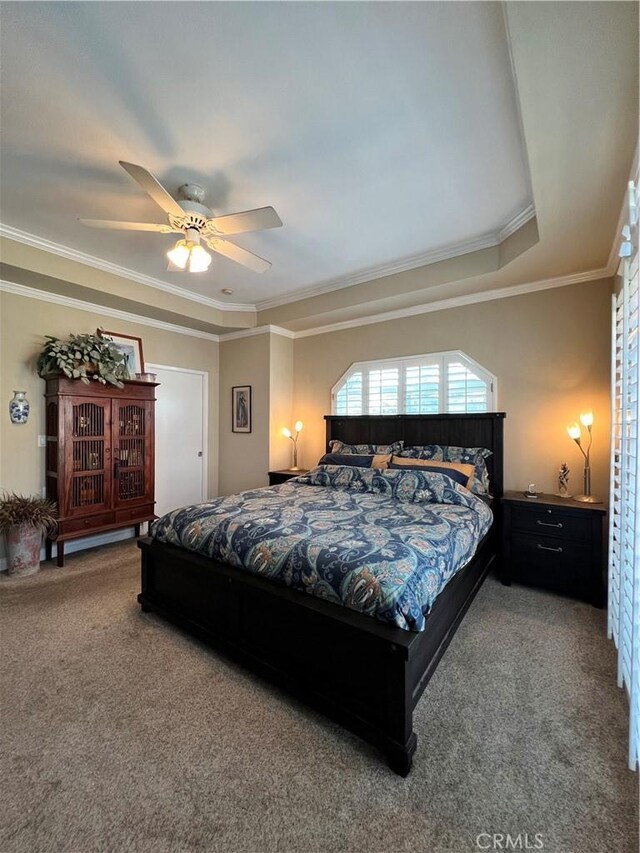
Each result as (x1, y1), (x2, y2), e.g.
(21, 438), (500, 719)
(45, 376), (156, 566)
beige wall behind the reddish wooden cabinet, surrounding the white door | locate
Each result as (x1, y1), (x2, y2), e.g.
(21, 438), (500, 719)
(0, 292), (218, 502)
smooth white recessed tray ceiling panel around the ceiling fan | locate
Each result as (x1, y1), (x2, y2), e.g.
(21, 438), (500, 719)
(0, 2), (532, 303)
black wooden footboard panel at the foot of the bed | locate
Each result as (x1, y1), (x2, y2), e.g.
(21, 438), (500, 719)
(138, 539), (417, 775)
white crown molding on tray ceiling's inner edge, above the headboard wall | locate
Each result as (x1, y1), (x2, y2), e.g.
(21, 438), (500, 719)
(256, 204), (536, 311)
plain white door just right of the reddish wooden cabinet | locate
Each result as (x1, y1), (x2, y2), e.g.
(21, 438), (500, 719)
(146, 364), (209, 515)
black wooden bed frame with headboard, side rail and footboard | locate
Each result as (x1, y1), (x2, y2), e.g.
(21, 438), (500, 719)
(138, 412), (505, 776)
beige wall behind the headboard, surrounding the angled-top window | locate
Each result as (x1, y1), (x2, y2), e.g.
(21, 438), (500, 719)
(294, 279), (613, 498)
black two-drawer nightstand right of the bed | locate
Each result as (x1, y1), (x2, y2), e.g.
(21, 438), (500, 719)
(501, 492), (606, 607)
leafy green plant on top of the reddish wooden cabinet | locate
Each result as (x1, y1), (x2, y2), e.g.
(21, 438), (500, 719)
(38, 335), (129, 388)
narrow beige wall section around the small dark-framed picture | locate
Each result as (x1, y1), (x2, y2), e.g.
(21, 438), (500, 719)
(219, 334), (270, 495)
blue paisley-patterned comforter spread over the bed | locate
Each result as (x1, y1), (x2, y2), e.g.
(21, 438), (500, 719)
(151, 465), (492, 631)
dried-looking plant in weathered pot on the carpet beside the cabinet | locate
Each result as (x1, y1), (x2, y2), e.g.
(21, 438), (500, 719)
(0, 492), (58, 576)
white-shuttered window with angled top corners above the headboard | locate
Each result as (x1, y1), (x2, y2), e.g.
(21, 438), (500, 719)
(331, 350), (497, 415)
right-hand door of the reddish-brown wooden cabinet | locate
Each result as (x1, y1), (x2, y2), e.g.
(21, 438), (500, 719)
(112, 400), (153, 507)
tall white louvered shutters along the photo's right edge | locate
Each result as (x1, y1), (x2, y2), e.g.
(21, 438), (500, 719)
(607, 176), (640, 769)
